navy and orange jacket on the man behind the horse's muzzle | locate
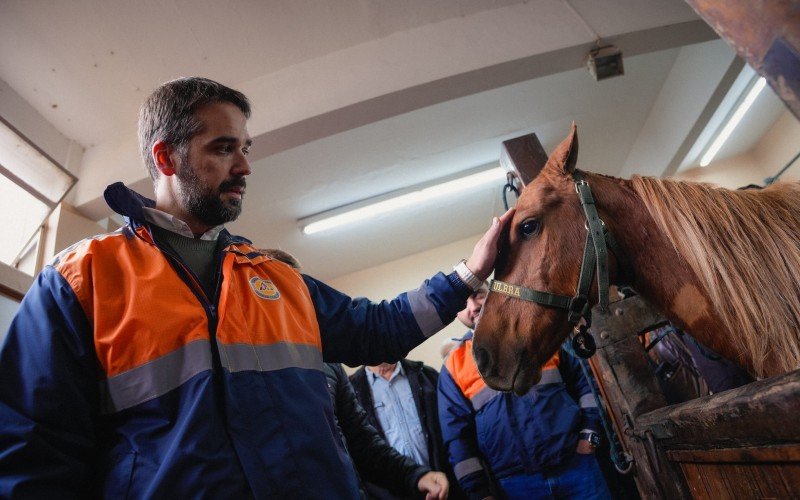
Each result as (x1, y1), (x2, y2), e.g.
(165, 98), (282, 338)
(439, 332), (600, 498)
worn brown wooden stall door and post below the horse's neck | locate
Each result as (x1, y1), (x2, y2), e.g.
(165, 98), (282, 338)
(590, 297), (800, 500)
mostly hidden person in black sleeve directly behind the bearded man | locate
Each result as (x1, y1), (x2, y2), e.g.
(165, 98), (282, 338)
(259, 248), (449, 500)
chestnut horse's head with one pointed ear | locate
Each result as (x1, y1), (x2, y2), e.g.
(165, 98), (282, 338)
(473, 124), (586, 394)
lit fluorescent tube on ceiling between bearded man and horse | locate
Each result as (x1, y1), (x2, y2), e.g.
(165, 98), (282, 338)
(298, 166), (506, 234)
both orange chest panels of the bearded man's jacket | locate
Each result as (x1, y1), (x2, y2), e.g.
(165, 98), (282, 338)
(55, 228), (322, 377)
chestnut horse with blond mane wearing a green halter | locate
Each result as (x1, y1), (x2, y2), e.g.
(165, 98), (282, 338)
(473, 124), (800, 394)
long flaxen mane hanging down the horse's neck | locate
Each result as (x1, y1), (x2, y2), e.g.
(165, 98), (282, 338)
(631, 177), (800, 376)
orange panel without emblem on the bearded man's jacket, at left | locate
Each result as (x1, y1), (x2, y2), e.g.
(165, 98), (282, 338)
(55, 232), (208, 377)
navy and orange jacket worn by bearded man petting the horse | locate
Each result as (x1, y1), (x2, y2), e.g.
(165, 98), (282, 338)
(0, 183), (469, 499)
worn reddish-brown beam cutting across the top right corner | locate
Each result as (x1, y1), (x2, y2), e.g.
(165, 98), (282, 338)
(686, 0), (800, 119)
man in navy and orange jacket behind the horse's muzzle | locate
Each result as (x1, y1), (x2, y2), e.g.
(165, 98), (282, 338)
(439, 287), (610, 500)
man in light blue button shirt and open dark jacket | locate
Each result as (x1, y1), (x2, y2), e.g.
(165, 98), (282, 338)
(350, 359), (464, 499)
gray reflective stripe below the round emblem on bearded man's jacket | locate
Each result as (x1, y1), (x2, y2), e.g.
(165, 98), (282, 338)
(218, 342), (322, 372)
